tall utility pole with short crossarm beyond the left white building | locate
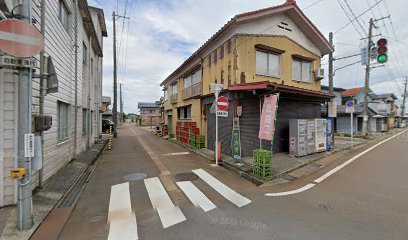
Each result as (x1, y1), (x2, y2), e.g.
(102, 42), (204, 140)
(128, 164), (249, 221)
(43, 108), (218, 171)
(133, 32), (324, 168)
(112, 11), (129, 138)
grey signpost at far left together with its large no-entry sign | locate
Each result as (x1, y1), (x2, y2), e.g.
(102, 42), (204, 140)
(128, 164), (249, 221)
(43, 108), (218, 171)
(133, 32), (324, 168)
(0, 6), (44, 230)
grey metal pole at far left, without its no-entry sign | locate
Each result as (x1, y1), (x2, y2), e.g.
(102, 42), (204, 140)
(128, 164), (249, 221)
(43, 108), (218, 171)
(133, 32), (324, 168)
(17, 0), (34, 230)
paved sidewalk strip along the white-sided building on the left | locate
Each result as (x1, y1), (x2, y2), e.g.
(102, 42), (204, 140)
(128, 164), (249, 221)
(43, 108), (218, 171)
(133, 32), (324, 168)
(0, 136), (107, 240)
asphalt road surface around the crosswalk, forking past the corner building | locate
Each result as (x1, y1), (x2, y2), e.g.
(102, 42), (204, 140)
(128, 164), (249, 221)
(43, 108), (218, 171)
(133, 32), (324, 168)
(59, 126), (408, 240)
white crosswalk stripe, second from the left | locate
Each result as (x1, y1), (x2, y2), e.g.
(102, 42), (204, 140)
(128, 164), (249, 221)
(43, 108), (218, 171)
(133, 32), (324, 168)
(144, 177), (186, 228)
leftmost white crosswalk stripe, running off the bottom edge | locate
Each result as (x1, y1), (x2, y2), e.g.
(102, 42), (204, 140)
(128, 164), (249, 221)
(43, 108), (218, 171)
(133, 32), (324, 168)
(108, 182), (138, 240)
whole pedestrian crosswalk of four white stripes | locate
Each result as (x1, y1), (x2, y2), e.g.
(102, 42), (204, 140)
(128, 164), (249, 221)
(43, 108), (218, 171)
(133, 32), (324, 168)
(108, 169), (251, 240)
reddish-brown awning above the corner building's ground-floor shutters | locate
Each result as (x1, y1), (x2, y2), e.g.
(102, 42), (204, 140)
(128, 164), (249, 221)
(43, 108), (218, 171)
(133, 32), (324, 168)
(228, 82), (336, 99)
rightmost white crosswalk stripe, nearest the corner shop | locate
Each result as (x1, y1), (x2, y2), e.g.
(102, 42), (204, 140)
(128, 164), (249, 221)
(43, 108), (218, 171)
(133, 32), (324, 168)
(193, 169), (251, 207)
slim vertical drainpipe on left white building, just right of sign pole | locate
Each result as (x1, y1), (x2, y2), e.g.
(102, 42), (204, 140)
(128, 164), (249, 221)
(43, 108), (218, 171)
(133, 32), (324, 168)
(38, 0), (47, 188)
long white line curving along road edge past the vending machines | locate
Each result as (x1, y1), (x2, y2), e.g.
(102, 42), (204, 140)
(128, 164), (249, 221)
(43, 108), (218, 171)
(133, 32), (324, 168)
(265, 129), (408, 197)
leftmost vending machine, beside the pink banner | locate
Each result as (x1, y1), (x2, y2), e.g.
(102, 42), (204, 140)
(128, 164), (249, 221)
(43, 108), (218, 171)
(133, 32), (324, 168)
(289, 119), (307, 157)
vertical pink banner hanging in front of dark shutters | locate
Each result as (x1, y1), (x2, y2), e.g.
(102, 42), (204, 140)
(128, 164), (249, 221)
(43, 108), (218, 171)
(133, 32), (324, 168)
(258, 95), (278, 141)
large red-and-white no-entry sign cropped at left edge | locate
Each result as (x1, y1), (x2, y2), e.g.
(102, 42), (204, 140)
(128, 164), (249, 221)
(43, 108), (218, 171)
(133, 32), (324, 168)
(0, 19), (44, 57)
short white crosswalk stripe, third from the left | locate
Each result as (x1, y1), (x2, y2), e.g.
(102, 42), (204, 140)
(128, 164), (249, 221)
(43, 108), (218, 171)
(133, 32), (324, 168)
(177, 181), (216, 212)
